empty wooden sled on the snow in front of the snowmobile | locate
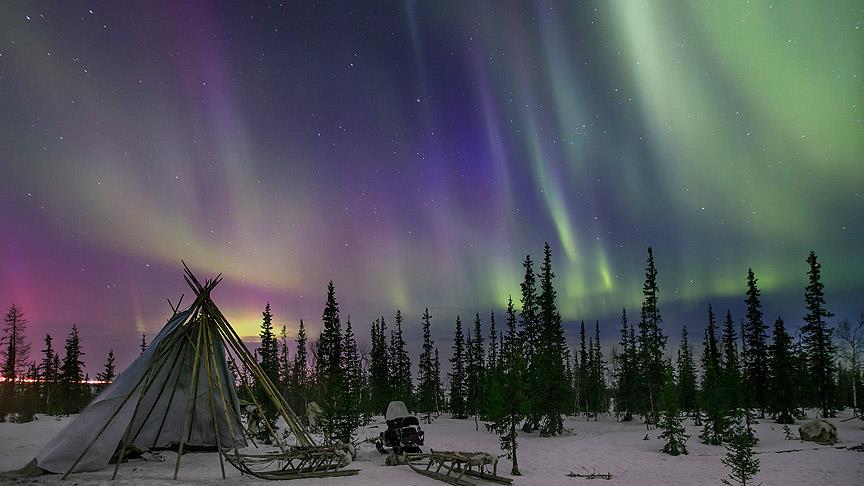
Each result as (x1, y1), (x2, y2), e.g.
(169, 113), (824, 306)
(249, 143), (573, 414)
(405, 450), (513, 486)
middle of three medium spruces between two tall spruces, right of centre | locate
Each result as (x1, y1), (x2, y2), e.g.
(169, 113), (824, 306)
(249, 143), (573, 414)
(699, 304), (727, 445)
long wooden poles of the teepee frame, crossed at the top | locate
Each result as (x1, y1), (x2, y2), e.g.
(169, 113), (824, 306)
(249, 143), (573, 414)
(63, 262), (316, 479)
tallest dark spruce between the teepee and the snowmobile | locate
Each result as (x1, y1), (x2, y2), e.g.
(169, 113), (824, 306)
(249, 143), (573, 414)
(315, 280), (345, 443)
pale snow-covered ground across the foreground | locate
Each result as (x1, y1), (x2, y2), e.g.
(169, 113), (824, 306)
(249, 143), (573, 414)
(0, 415), (864, 486)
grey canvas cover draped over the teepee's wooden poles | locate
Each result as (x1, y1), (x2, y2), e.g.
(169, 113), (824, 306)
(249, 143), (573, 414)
(36, 308), (246, 473)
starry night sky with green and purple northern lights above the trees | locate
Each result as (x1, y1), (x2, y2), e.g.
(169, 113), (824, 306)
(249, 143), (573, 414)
(0, 0), (864, 374)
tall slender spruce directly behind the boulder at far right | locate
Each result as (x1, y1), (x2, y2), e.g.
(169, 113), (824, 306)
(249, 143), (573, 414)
(801, 251), (837, 417)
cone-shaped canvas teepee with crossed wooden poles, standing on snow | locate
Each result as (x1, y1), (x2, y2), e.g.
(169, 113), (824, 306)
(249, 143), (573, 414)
(20, 263), (357, 479)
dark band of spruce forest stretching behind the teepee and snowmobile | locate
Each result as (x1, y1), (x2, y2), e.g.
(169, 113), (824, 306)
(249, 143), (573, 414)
(0, 244), (864, 472)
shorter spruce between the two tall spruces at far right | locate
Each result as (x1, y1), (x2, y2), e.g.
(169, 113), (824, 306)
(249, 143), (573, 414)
(768, 317), (796, 424)
